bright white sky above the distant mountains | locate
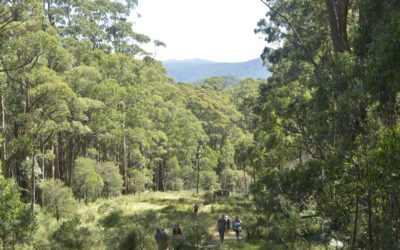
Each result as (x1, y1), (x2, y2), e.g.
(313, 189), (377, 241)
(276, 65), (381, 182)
(134, 0), (267, 62)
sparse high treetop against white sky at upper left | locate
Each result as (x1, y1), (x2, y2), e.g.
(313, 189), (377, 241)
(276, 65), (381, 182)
(41, 0), (150, 56)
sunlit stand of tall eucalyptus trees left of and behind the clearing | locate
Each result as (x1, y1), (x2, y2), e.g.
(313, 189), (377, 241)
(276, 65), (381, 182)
(0, 0), (250, 204)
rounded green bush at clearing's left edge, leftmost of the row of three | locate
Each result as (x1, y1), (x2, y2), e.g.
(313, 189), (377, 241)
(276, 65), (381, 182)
(39, 179), (76, 220)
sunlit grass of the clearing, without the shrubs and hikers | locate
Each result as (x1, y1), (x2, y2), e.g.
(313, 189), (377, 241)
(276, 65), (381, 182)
(29, 191), (258, 250)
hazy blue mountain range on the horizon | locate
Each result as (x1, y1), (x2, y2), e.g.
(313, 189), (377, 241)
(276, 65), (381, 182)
(163, 59), (270, 82)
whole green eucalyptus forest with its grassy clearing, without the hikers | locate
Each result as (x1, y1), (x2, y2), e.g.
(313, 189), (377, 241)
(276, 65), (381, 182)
(0, 0), (400, 250)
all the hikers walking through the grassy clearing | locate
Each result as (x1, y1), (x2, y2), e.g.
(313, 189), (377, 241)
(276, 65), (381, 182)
(154, 203), (242, 250)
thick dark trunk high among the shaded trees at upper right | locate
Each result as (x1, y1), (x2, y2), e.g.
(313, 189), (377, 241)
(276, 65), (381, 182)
(325, 0), (350, 53)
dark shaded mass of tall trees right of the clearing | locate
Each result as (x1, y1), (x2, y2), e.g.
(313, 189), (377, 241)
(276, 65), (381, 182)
(252, 0), (400, 249)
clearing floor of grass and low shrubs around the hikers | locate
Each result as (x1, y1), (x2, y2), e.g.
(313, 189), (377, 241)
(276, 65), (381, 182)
(27, 191), (323, 250)
